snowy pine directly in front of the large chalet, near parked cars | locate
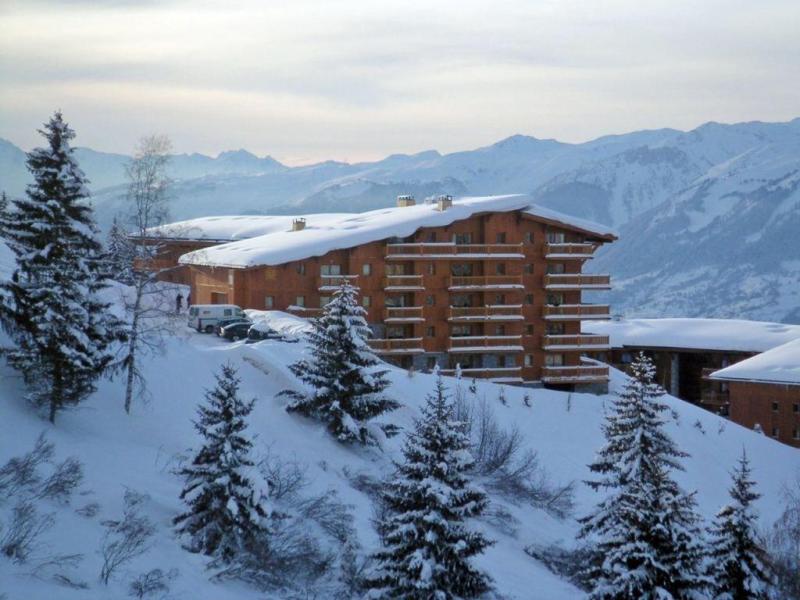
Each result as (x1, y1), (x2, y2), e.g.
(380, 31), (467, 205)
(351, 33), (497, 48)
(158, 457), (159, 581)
(281, 282), (399, 444)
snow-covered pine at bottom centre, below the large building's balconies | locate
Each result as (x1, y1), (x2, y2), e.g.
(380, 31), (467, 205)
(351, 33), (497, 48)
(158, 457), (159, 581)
(368, 377), (492, 600)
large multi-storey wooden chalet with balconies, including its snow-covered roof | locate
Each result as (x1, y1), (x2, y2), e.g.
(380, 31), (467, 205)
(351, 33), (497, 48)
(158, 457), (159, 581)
(159, 196), (616, 389)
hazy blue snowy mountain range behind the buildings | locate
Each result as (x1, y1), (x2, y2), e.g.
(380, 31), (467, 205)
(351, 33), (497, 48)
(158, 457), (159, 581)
(0, 118), (800, 323)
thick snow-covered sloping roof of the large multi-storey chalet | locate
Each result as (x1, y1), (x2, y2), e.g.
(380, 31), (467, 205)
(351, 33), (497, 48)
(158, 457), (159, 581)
(180, 194), (614, 268)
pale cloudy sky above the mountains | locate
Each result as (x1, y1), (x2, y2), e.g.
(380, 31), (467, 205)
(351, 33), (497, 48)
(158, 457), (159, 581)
(0, 0), (800, 164)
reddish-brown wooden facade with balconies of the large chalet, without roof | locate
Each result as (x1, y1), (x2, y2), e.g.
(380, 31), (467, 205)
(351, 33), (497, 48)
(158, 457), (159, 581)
(180, 204), (614, 386)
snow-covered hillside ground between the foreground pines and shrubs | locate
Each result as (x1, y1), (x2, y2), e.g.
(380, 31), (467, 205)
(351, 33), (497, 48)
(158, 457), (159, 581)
(0, 312), (800, 600)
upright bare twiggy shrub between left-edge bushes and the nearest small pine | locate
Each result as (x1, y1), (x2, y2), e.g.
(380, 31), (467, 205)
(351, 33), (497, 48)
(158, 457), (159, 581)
(100, 490), (156, 585)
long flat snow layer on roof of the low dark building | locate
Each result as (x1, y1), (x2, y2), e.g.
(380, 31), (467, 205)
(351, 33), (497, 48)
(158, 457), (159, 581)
(583, 319), (800, 352)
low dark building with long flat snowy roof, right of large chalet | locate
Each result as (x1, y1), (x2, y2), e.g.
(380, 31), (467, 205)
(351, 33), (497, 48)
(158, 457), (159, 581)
(591, 318), (800, 412)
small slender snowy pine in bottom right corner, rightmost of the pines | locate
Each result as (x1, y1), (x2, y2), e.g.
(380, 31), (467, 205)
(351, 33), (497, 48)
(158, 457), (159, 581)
(708, 451), (770, 600)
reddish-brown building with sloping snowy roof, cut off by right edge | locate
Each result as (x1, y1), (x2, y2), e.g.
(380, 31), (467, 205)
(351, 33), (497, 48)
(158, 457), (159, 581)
(709, 339), (800, 448)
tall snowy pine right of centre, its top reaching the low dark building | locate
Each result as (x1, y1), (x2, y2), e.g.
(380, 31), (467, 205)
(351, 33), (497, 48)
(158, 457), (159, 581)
(580, 354), (707, 600)
